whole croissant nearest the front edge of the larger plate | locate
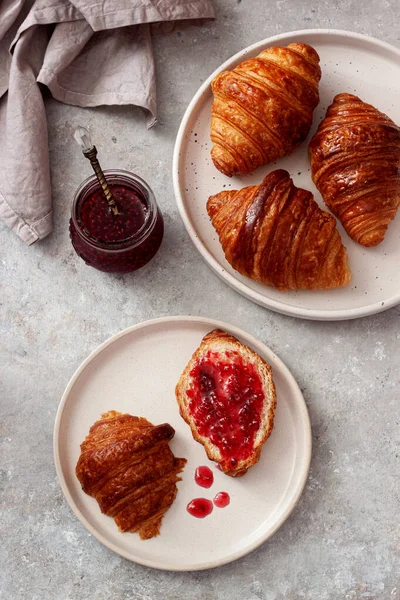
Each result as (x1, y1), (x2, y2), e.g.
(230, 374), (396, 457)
(207, 169), (351, 290)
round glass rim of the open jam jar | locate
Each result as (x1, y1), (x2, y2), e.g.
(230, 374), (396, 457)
(71, 169), (158, 253)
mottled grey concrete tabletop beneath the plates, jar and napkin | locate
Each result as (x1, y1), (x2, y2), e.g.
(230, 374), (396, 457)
(0, 0), (400, 600)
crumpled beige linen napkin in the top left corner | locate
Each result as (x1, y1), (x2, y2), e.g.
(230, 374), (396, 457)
(0, 0), (214, 244)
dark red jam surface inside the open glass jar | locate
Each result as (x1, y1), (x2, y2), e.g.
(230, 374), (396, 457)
(80, 185), (147, 243)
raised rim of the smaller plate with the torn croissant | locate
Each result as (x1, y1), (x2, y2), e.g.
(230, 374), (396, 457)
(53, 315), (312, 572)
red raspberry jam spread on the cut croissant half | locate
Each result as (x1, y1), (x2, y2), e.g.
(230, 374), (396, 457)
(187, 350), (265, 471)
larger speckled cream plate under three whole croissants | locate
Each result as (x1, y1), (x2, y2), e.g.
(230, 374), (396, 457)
(173, 30), (400, 320)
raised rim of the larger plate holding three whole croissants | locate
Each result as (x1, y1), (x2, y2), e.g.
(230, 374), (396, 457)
(172, 29), (400, 321)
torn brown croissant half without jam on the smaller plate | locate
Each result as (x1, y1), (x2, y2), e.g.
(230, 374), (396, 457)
(76, 411), (186, 539)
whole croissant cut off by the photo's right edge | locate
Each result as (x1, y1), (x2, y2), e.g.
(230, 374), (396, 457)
(309, 94), (400, 246)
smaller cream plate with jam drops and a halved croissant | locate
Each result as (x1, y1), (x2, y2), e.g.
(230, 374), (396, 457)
(54, 317), (311, 571)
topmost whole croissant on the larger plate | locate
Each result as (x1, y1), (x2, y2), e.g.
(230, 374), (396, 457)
(211, 43), (321, 177)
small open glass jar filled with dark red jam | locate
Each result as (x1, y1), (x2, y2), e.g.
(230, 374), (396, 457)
(69, 169), (164, 273)
